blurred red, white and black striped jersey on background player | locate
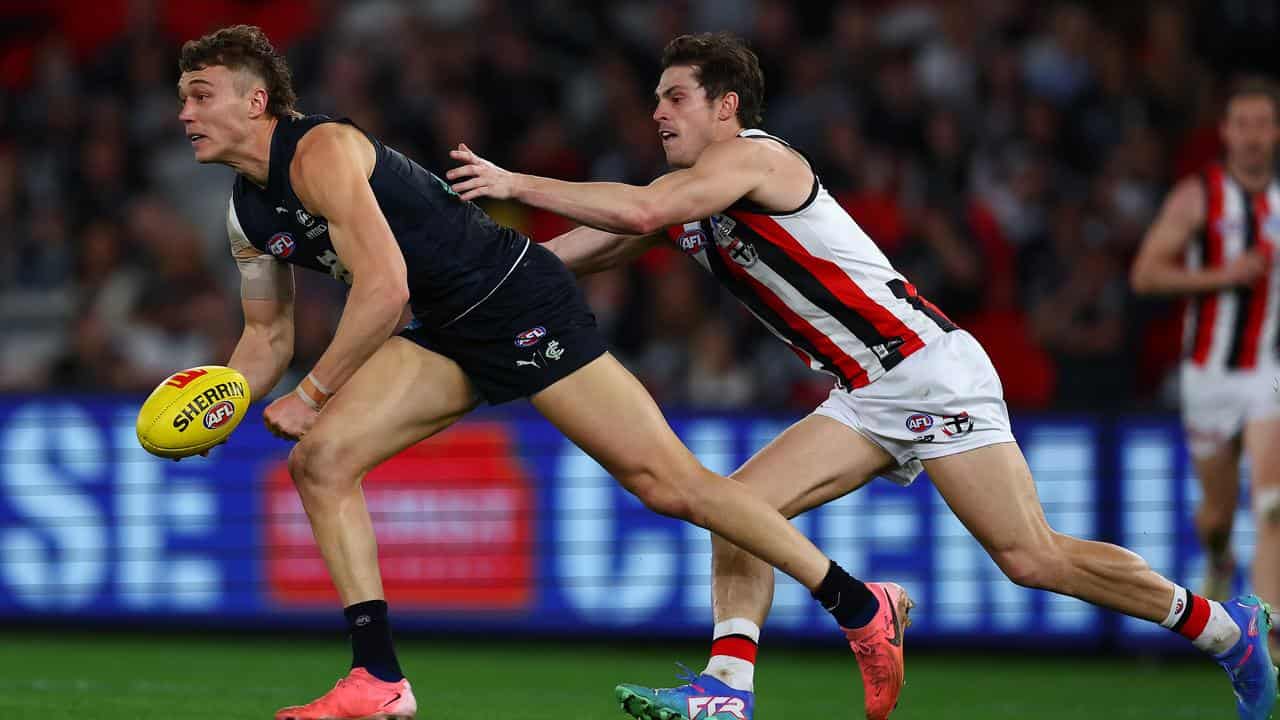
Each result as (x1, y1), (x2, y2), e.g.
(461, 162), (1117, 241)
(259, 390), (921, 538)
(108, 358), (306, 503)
(1183, 165), (1280, 369)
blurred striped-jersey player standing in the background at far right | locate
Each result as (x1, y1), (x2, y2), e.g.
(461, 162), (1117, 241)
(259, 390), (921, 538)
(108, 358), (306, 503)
(1132, 78), (1280, 652)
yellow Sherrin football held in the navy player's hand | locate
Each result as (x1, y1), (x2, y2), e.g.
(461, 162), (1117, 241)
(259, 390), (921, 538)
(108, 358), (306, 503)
(137, 365), (252, 457)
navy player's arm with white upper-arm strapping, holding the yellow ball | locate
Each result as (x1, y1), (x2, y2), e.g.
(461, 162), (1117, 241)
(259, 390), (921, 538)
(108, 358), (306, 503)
(227, 205), (293, 397)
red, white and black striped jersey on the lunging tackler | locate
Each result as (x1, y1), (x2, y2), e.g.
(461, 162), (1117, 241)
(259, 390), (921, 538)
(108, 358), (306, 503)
(667, 129), (955, 389)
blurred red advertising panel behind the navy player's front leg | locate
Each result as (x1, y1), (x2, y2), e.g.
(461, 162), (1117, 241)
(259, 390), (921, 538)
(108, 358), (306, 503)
(264, 423), (535, 611)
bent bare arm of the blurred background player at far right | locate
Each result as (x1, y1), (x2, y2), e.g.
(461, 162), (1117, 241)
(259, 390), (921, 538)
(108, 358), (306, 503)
(1129, 177), (1270, 295)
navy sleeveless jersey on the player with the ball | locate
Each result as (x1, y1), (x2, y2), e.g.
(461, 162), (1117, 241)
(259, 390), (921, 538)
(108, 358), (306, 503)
(230, 115), (529, 325)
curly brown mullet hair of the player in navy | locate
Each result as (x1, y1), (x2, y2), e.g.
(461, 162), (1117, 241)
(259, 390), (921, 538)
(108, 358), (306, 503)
(178, 26), (298, 118)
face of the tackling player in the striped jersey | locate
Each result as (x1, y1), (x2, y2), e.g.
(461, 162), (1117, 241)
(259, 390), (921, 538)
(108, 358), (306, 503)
(653, 65), (716, 168)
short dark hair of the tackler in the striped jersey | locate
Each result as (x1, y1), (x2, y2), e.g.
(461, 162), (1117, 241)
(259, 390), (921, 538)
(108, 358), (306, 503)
(662, 32), (764, 128)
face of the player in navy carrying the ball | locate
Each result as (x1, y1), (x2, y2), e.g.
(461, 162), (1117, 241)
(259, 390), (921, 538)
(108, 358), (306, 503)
(178, 65), (252, 163)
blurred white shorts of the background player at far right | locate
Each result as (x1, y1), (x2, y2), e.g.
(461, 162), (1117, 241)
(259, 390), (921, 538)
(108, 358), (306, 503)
(1181, 363), (1280, 457)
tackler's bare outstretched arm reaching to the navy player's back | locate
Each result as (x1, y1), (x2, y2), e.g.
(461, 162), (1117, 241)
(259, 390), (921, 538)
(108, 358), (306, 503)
(445, 138), (773, 234)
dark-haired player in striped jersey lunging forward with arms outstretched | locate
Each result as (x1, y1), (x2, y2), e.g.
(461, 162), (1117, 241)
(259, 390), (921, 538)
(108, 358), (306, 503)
(447, 33), (1276, 720)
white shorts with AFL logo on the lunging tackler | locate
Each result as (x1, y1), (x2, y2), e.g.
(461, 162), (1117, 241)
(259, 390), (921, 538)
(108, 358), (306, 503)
(813, 331), (1014, 486)
